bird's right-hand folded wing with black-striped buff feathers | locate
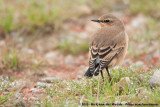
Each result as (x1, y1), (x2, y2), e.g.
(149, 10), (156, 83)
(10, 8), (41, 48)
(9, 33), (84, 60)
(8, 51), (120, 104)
(98, 32), (126, 70)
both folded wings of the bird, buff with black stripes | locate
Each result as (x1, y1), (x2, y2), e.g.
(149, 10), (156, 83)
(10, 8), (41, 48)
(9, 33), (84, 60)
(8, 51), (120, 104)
(89, 32), (125, 72)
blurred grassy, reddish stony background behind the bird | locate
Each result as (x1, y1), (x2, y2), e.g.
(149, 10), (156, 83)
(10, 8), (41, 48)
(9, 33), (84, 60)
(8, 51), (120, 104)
(0, 0), (160, 105)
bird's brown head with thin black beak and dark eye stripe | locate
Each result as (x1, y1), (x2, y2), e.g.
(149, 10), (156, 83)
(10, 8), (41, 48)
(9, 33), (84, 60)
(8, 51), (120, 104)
(91, 14), (123, 27)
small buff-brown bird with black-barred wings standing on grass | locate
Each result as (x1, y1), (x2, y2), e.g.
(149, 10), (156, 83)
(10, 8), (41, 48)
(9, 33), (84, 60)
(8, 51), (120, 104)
(84, 13), (128, 81)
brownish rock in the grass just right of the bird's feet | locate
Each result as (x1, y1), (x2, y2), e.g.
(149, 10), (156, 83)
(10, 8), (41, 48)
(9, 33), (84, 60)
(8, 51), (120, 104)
(112, 77), (131, 93)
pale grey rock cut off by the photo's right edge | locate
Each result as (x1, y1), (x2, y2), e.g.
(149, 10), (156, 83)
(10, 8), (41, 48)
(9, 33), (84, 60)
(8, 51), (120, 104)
(149, 70), (160, 87)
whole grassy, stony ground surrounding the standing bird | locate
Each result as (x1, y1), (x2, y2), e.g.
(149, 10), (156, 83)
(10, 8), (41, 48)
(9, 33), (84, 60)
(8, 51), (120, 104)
(0, 0), (160, 107)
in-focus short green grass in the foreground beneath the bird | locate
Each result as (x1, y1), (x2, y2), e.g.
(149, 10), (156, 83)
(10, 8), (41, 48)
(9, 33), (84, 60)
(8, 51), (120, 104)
(0, 67), (160, 107)
